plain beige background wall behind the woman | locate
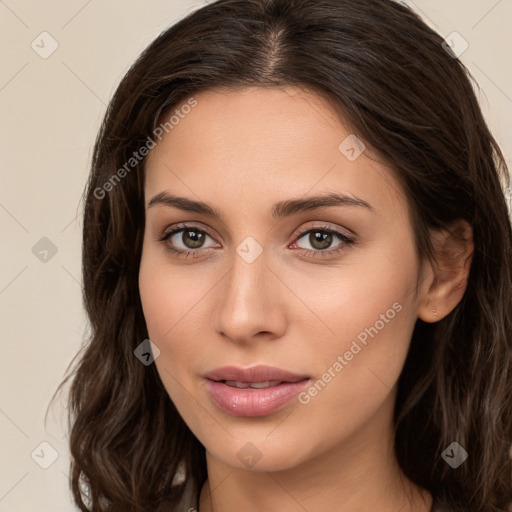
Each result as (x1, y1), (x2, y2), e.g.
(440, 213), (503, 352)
(0, 0), (512, 512)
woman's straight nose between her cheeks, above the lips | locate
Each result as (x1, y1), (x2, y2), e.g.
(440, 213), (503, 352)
(213, 246), (286, 344)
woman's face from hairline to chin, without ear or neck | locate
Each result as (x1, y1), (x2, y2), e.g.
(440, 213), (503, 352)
(139, 87), (428, 471)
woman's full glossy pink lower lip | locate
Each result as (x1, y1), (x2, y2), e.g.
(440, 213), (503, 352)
(206, 379), (309, 416)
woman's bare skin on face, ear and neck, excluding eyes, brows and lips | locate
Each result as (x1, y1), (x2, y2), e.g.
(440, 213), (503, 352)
(139, 87), (472, 512)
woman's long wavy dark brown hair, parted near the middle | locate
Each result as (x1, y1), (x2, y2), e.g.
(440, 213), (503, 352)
(52, 0), (512, 512)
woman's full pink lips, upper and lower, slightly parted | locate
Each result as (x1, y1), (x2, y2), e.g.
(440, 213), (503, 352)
(204, 365), (309, 416)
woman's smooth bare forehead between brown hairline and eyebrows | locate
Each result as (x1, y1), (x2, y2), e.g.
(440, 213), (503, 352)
(145, 87), (405, 222)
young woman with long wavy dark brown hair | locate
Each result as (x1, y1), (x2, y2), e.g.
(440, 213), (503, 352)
(56, 0), (512, 512)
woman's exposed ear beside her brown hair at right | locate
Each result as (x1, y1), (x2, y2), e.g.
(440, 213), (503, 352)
(418, 219), (474, 323)
